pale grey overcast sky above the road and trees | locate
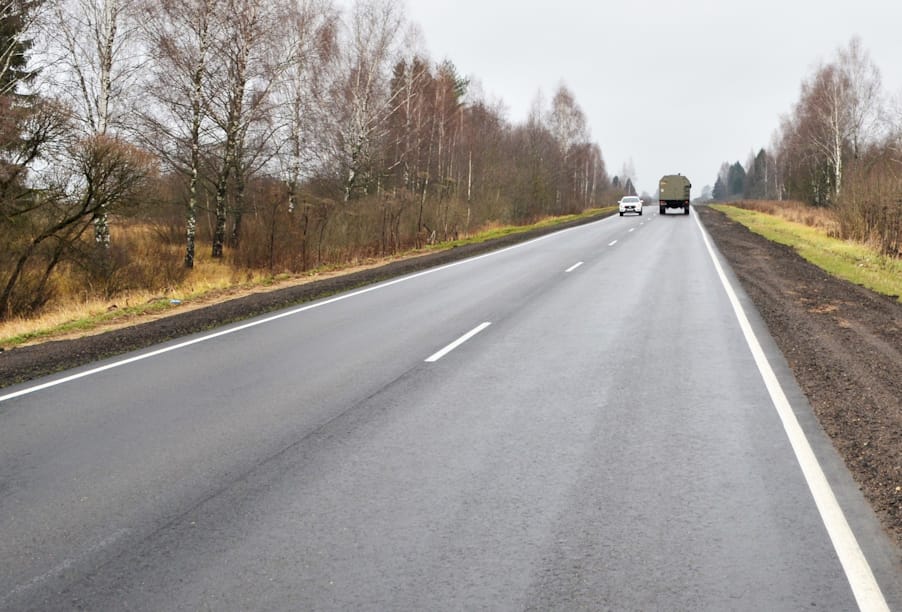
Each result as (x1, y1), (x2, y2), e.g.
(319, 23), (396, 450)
(406, 0), (902, 197)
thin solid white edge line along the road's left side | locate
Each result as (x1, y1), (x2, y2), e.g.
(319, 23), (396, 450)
(0, 217), (613, 403)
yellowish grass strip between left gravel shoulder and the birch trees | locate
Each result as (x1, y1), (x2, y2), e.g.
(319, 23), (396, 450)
(0, 207), (616, 349)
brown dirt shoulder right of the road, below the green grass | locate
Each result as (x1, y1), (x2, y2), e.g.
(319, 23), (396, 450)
(696, 206), (902, 546)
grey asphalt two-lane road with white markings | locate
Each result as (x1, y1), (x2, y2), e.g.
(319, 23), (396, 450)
(0, 209), (902, 610)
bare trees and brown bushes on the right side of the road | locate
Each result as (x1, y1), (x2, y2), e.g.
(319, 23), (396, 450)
(711, 38), (902, 256)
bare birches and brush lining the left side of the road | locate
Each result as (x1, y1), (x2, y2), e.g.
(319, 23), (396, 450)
(0, 0), (613, 318)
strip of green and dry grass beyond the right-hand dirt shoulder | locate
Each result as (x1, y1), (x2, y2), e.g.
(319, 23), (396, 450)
(712, 204), (902, 301)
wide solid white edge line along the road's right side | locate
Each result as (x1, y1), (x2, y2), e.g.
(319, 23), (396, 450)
(694, 213), (889, 612)
